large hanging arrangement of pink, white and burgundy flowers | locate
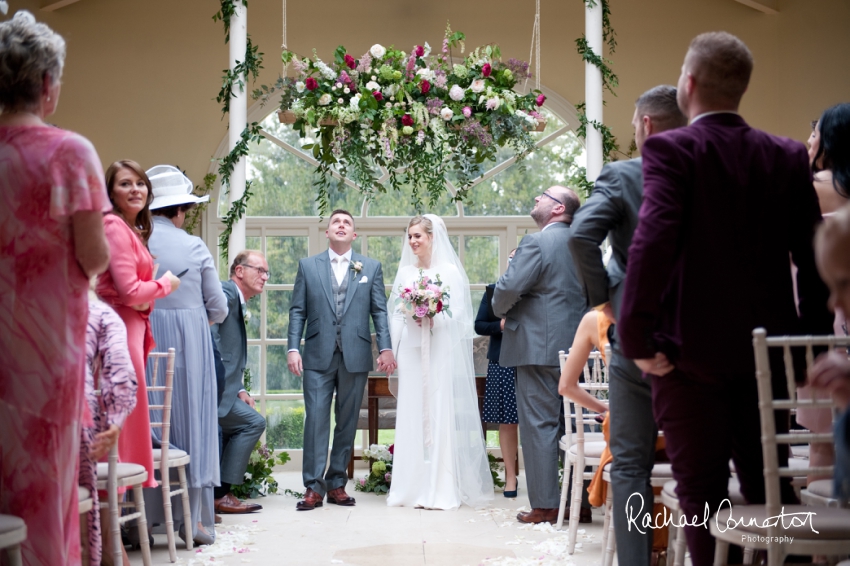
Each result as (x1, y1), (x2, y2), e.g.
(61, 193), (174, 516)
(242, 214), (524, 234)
(260, 27), (546, 215)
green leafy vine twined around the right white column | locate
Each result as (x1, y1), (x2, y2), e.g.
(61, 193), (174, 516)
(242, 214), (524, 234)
(576, 0), (631, 197)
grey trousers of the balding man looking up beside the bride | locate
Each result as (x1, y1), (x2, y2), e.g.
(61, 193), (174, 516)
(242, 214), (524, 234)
(516, 366), (563, 509)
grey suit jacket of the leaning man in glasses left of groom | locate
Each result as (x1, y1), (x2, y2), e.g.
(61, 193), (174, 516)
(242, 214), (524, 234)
(210, 279), (248, 418)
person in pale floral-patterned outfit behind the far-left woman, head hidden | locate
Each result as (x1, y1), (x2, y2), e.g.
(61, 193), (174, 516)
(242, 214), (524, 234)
(80, 293), (137, 566)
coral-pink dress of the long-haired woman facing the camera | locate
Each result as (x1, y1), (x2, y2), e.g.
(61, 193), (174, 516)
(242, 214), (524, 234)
(97, 214), (171, 487)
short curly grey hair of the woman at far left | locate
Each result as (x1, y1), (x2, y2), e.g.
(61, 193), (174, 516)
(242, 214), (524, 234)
(0, 10), (65, 114)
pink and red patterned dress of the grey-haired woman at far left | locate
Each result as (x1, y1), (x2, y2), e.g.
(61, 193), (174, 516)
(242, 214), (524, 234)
(0, 126), (111, 566)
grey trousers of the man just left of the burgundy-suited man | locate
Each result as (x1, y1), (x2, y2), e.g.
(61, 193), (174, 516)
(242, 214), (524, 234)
(608, 350), (658, 566)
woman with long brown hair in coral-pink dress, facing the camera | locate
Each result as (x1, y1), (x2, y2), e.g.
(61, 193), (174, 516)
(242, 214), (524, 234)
(97, 160), (180, 487)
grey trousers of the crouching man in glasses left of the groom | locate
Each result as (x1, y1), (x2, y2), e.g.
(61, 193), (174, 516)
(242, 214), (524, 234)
(219, 399), (266, 485)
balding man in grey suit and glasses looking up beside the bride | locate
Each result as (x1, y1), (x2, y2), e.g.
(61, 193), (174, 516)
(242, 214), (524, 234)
(493, 186), (587, 523)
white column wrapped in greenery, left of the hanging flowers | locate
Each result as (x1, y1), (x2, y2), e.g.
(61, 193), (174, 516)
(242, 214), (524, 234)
(227, 0), (248, 265)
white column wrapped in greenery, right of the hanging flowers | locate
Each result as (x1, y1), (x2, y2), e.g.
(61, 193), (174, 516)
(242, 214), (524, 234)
(584, 0), (602, 181)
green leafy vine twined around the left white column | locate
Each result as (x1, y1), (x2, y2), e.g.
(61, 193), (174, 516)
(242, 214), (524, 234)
(212, 0), (263, 260)
